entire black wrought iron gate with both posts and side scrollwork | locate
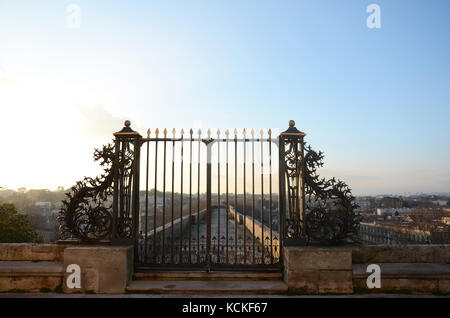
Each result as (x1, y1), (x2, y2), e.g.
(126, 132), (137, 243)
(58, 121), (359, 270)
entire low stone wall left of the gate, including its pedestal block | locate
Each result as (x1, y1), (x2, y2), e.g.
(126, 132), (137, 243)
(0, 243), (133, 293)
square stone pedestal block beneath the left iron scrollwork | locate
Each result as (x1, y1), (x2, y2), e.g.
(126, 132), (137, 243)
(63, 246), (133, 294)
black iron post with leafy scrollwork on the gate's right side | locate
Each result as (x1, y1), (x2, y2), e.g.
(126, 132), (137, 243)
(280, 121), (359, 245)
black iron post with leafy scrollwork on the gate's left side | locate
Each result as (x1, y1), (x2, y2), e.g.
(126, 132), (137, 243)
(57, 124), (135, 242)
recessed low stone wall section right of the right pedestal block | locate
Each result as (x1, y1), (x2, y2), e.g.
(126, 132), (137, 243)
(351, 245), (450, 294)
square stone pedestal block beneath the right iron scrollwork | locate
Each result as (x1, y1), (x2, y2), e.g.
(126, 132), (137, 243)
(283, 247), (353, 294)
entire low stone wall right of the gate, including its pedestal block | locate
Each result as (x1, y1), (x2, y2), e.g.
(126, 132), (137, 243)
(283, 245), (450, 294)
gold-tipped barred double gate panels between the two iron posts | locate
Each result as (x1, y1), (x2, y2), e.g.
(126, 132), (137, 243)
(127, 129), (280, 270)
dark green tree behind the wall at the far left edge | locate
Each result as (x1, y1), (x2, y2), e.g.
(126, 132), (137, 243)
(0, 203), (42, 243)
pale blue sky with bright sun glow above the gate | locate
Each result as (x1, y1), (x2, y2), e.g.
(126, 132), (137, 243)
(0, 0), (450, 194)
